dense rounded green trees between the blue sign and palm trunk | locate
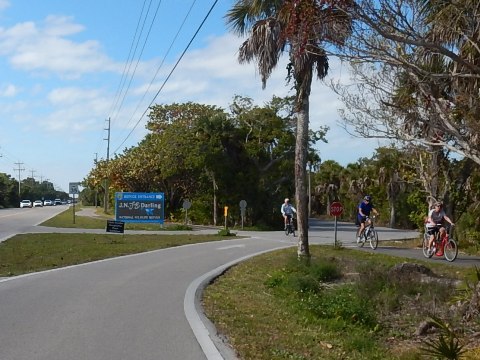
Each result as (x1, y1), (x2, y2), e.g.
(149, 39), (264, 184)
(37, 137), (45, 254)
(86, 96), (298, 227)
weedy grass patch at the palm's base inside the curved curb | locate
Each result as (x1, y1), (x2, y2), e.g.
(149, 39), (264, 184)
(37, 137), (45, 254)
(203, 246), (479, 360)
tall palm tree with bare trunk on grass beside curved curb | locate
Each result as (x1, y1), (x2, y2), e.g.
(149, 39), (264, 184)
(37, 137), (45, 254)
(226, 0), (351, 257)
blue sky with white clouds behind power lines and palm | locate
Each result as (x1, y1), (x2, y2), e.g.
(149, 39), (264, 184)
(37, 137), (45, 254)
(0, 0), (384, 191)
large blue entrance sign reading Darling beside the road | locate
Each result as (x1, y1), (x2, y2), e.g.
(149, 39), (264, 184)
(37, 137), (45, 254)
(115, 192), (165, 224)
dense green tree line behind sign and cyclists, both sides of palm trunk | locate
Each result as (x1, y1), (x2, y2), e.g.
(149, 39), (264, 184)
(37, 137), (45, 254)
(80, 96), (480, 250)
